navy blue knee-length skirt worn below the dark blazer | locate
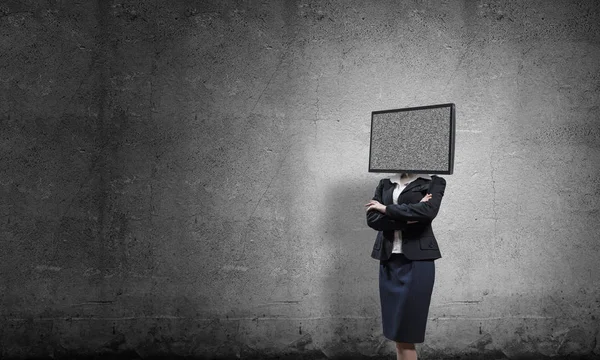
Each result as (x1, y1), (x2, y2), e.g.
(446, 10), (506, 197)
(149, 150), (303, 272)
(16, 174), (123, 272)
(379, 254), (435, 344)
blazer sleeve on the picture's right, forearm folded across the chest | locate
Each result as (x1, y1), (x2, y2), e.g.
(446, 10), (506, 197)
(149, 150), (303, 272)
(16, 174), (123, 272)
(385, 175), (446, 222)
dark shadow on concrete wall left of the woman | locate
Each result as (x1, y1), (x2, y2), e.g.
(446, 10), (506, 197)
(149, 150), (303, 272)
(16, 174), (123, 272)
(321, 174), (391, 357)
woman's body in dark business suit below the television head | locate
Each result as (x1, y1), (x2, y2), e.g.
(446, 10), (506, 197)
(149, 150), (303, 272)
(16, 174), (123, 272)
(365, 174), (446, 360)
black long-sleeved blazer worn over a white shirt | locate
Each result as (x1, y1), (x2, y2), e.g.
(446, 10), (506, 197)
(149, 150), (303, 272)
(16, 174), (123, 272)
(367, 175), (446, 260)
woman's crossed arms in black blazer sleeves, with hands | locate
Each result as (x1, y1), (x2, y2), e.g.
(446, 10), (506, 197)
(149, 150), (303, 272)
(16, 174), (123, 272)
(365, 176), (446, 231)
